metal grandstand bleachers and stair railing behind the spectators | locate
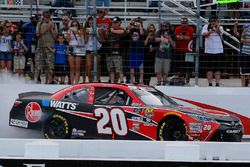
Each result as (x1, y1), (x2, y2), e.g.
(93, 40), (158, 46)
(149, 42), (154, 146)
(0, 0), (249, 87)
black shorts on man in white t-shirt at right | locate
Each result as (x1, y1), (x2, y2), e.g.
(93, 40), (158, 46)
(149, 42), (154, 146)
(202, 53), (226, 73)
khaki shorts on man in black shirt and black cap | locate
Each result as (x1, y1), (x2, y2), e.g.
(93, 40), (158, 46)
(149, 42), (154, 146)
(106, 55), (122, 72)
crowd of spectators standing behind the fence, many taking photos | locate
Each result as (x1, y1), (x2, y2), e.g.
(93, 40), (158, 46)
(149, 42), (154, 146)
(0, 6), (250, 86)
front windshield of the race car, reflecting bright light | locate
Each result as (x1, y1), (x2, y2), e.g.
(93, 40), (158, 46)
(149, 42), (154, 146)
(130, 87), (178, 106)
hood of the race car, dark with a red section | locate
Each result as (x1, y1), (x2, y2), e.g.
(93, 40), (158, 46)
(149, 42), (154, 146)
(155, 105), (239, 121)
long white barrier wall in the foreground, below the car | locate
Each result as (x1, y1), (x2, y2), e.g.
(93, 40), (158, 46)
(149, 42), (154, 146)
(0, 139), (250, 162)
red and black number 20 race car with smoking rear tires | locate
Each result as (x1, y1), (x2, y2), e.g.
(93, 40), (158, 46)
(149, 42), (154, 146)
(9, 83), (243, 141)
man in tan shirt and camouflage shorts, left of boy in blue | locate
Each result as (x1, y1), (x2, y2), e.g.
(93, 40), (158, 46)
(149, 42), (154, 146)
(35, 11), (57, 84)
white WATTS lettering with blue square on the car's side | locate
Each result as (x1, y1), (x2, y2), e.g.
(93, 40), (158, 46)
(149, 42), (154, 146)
(42, 100), (77, 110)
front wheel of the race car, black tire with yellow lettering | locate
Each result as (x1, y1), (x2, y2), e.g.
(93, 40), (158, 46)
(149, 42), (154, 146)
(158, 117), (188, 141)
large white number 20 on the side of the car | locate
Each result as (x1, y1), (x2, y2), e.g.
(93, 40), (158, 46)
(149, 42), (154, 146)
(94, 108), (128, 136)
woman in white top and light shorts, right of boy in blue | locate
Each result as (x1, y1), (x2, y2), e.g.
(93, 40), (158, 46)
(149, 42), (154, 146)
(66, 20), (86, 84)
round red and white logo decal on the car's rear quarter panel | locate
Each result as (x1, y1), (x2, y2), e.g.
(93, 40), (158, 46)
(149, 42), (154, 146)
(25, 102), (42, 123)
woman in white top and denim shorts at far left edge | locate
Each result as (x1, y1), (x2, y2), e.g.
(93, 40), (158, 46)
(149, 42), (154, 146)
(0, 21), (13, 71)
